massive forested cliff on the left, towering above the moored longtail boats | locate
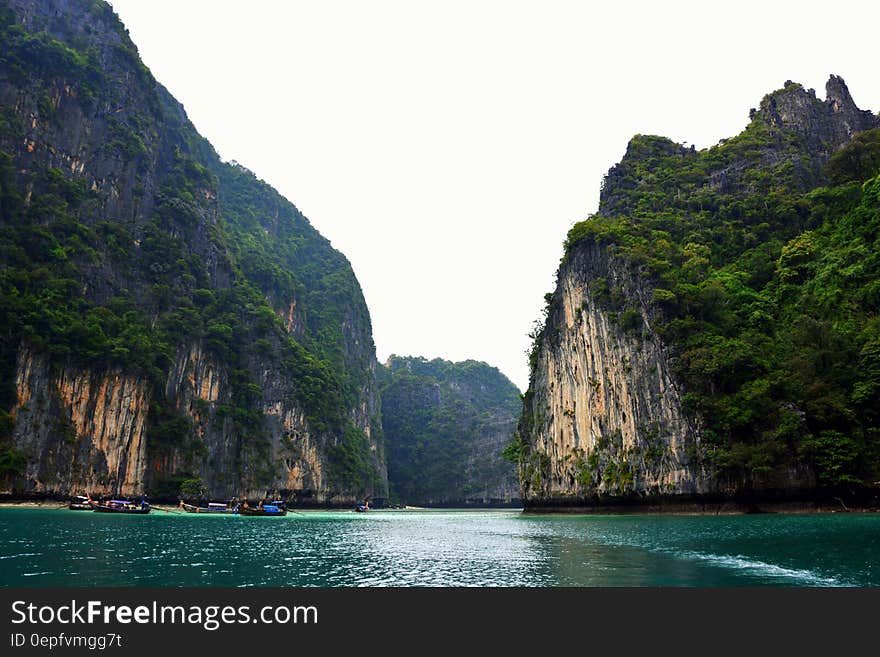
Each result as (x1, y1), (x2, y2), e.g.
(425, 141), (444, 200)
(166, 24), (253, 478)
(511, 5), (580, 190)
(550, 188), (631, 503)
(0, 0), (387, 504)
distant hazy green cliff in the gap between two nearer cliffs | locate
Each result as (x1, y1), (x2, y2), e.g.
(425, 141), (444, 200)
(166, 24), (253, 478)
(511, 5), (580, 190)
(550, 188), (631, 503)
(380, 356), (520, 506)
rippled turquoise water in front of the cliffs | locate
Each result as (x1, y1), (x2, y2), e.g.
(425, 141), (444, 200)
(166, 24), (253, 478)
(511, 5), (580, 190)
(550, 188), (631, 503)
(0, 508), (880, 587)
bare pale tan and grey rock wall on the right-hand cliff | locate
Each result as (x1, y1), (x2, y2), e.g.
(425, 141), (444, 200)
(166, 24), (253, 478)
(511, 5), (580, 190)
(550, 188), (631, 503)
(520, 244), (710, 505)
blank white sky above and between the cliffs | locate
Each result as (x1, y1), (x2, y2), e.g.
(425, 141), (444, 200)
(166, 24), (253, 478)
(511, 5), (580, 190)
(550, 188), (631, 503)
(111, 0), (880, 391)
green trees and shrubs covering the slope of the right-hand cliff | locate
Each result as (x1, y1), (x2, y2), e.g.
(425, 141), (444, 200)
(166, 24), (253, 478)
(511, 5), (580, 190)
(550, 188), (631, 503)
(556, 78), (880, 490)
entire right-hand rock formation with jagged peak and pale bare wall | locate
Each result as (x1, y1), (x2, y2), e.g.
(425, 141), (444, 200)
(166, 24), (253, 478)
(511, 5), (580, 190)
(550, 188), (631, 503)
(515, 76), (880, 508)
